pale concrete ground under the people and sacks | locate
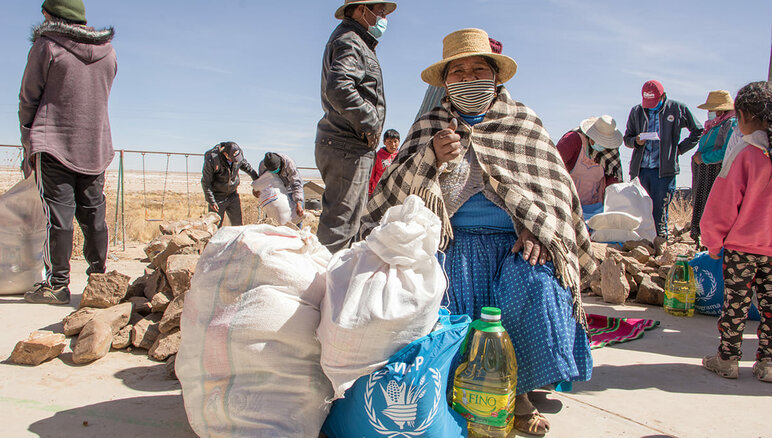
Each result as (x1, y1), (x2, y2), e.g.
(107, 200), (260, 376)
(0, 246), (772, 438)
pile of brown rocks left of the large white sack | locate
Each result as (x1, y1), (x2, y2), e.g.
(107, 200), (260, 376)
(10, 213), (220, 370)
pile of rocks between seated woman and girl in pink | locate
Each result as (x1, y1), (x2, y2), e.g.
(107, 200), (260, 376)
(582, 237), (695, 306)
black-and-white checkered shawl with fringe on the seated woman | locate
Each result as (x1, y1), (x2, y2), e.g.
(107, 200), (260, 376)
(360, 86), (596, 327)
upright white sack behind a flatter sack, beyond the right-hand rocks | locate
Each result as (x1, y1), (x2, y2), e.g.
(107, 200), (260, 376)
(603, 177), (657, 242)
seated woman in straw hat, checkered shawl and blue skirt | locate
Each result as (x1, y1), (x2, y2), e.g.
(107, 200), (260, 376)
(360, 29), (595, 435)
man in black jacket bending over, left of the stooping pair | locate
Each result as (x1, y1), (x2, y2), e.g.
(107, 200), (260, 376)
(201, 141), (257, 226)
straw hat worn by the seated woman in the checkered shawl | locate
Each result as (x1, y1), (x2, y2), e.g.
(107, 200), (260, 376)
(421, 29), (517, 87)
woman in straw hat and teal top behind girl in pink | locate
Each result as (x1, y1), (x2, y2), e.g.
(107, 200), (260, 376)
(689, 90), (737, 248)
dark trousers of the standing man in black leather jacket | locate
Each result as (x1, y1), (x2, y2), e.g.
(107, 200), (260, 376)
(316, 144), (375, 253)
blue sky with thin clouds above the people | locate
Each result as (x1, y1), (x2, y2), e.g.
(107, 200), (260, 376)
(0, 0), (772, 186)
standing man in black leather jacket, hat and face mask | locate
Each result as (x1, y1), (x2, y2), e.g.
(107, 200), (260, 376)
(316, 0), (397, 252)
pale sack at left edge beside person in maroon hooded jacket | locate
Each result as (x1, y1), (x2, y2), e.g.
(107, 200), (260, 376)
(0, 176), (48, 295)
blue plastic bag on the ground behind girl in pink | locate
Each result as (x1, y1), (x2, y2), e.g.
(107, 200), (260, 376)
(689, 249), (759, 321)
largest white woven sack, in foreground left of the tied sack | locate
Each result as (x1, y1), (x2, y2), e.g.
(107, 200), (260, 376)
(176, 225), (332, 437)
